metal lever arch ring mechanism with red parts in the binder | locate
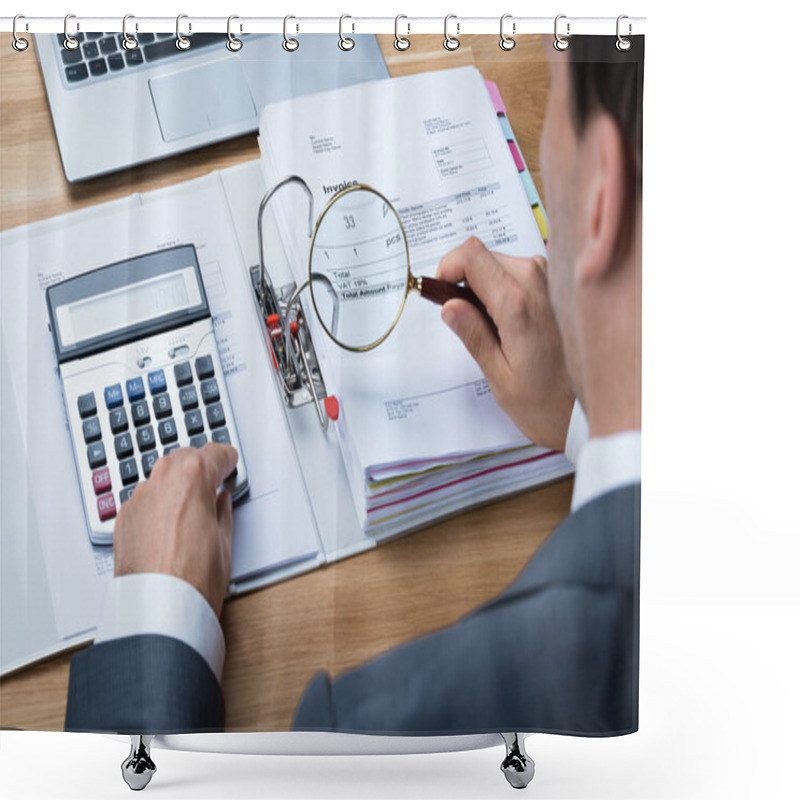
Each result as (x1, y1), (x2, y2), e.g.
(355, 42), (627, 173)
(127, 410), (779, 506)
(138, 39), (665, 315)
(250, 175), (328, 430)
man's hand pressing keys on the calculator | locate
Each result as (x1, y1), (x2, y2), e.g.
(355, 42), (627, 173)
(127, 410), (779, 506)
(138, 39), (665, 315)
(114, 442), (239, 616)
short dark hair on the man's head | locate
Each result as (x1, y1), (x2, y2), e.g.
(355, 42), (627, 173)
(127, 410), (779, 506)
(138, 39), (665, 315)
(566, 36), (644, 255)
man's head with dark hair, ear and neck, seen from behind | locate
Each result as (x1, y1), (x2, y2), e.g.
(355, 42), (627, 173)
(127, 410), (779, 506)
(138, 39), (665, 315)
(541, 36), (644, 435)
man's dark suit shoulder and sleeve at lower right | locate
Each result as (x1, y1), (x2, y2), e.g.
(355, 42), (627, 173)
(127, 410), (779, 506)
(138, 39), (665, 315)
(294, 485), (640, 736)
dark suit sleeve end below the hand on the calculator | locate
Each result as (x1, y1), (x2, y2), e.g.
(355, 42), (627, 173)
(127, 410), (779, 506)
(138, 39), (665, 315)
(64, 634), (225, 734)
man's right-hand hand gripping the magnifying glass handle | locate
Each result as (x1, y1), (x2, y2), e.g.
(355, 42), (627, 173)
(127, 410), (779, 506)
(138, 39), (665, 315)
(436, 237), (575, 450)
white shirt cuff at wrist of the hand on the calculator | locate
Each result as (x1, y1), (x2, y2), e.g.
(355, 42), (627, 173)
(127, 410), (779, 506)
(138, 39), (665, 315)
(94, 572), (225, 683)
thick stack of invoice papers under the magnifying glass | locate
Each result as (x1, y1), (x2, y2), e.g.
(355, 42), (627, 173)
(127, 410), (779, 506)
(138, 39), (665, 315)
(259, 67), (571, 533)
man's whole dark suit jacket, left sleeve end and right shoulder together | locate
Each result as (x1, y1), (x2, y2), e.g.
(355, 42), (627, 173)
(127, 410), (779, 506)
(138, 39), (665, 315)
(65, 485), (640, 736)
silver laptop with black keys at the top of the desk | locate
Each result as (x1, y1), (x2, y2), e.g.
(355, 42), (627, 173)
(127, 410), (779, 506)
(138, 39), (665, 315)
(35, 33), (388, 182)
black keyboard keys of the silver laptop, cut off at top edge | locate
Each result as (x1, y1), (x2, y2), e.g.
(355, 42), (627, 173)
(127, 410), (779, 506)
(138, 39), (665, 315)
(56, 33), (228, 83)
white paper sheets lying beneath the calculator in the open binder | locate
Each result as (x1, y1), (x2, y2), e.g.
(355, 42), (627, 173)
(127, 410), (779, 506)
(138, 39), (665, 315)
(0, 173), (319, 638)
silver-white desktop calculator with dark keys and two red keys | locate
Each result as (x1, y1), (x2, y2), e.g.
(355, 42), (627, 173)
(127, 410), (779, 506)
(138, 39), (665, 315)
(46, 245), (248, 545)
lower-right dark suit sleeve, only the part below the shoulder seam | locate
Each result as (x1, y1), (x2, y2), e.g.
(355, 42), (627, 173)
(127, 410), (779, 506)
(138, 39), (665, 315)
(294, 585), (637, 735)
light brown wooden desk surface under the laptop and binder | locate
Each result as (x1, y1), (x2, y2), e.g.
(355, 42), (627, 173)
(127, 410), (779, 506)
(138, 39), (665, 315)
(0, 34), (572, 731)
